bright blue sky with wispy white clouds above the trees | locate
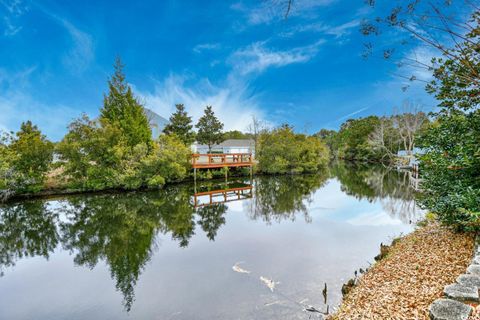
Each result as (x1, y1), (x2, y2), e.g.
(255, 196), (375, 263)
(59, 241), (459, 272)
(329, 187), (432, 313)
(0, 0), (446, 140)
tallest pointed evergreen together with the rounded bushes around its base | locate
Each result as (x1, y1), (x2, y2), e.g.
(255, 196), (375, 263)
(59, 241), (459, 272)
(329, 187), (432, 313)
(57, 59), (191, 190)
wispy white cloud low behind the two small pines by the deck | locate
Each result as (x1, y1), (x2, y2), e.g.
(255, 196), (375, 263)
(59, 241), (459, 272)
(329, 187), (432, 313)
(135, 75), (263, 131)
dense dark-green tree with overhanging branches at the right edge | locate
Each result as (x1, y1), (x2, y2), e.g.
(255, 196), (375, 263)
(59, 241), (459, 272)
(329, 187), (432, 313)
(354, 1), (480, 231)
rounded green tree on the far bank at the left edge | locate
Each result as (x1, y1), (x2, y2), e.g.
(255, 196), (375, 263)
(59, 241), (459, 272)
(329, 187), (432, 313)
(0, 121), (54, 193)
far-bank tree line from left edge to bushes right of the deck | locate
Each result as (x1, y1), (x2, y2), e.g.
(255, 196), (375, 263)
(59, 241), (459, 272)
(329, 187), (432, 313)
(0, 58), (328, 201)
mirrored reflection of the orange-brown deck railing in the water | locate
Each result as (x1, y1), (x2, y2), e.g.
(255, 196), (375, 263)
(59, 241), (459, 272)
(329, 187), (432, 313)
(193, 185), (252, 207)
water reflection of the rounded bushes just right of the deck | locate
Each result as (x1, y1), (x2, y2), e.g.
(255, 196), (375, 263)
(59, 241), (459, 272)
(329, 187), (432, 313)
(246, 171), (328, 223)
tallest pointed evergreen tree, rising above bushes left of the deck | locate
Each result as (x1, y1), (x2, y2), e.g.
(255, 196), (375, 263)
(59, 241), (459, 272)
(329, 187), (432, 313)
(100, 58), (152, 147)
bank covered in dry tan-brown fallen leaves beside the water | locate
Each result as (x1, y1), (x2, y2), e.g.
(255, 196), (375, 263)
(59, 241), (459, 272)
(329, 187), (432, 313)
(331, 224), (474, 320)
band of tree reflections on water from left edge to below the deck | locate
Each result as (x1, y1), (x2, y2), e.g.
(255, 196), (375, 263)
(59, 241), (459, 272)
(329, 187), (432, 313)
(0, 185), (227, 311)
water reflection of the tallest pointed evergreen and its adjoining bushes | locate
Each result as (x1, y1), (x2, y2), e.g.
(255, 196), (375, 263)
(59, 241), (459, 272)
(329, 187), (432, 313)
(57, 195), (161, 310)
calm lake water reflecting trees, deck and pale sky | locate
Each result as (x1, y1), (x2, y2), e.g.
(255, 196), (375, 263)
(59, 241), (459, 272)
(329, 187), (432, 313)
(0, 164), (421, 320)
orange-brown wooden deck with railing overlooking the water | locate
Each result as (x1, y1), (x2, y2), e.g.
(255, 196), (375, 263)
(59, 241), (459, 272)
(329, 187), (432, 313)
(192, 153), (253, 169)
